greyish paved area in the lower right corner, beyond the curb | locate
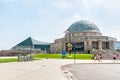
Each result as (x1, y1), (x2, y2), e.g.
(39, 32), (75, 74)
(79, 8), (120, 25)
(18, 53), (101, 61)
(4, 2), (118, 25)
(64, 64), (120, 80)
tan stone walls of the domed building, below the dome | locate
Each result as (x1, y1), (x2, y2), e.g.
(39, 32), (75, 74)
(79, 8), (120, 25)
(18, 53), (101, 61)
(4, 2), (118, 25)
(50, 36), (116, 53)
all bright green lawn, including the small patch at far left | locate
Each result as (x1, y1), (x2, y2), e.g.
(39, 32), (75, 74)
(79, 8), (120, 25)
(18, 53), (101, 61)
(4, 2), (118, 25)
(0, 54), (93, 63)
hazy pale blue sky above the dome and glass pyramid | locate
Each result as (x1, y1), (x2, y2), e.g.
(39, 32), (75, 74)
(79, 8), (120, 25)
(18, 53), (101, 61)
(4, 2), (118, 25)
(0, 0), (120, 50)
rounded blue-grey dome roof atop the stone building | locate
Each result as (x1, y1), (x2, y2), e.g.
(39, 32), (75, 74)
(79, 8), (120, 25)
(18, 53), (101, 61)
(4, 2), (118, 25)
(68, 20), (101, 33)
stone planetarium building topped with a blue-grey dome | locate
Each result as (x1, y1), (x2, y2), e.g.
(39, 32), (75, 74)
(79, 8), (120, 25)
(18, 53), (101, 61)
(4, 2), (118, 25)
(50, 20), (116, 53)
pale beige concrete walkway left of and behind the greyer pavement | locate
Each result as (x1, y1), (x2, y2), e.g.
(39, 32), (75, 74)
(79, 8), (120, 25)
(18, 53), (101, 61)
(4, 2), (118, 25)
(0, 59), (120, 80)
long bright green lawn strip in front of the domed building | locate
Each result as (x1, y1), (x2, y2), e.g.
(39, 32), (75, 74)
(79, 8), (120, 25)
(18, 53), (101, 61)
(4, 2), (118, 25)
(33, 54), (93, 60)
